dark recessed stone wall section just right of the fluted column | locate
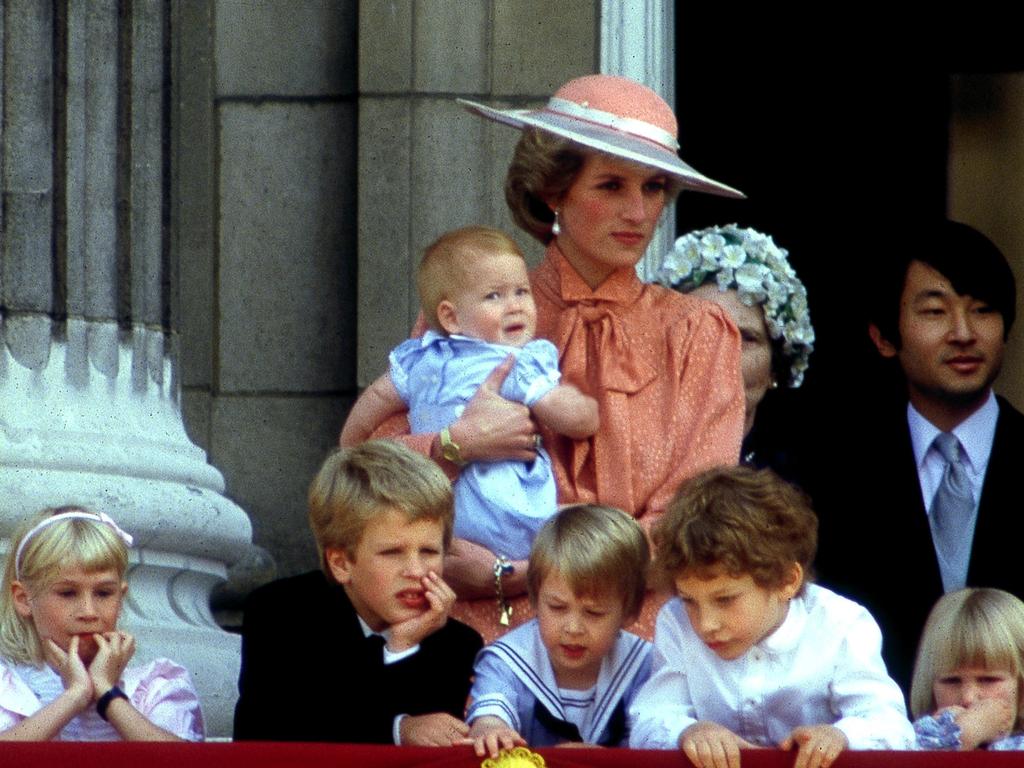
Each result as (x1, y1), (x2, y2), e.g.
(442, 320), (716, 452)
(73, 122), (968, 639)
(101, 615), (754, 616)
(173, 0), (357, 589)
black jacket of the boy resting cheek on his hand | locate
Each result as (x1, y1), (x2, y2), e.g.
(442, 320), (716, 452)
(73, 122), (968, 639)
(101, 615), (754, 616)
(234, 570), (481, 743)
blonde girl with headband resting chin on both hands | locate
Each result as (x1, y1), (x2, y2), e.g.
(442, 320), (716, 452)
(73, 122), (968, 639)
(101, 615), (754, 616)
(0, 507), (203, 741)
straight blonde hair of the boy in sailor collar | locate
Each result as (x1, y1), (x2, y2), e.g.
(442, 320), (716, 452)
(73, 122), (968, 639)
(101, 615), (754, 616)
(526, 504), (650, 617)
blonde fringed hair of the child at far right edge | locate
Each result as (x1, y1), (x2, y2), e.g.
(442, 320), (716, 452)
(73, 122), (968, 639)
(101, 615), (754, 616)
(910, 589), (1024, 731)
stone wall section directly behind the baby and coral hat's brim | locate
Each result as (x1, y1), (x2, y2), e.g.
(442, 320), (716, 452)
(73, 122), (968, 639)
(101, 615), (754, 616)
(358, 0), (601, 386)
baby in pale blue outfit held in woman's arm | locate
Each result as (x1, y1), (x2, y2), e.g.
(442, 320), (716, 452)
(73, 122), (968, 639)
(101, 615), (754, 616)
(341, 226), (598, 560)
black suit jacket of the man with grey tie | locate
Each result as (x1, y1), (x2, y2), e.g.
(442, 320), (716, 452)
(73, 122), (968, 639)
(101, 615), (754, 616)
(812, 397), (1024, 692)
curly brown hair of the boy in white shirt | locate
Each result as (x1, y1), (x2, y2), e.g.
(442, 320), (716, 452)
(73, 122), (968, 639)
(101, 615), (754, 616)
(654, 467), (818, 594)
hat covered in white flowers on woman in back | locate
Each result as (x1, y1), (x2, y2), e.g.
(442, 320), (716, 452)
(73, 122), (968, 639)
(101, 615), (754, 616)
(654, 224), (814, 387)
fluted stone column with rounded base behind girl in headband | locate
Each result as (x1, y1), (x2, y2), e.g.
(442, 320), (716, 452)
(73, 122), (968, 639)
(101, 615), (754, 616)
(0, 0), (251, 735)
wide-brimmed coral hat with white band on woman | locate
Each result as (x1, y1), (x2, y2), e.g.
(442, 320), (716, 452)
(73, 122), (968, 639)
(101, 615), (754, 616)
(458, 75), (746, 198)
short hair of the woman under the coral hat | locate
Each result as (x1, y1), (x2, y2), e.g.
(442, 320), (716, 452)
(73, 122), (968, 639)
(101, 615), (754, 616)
(505, 128), (683, 245)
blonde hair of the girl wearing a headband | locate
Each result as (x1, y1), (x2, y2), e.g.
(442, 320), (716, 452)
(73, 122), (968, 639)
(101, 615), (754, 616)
(0, 506), (128, 666)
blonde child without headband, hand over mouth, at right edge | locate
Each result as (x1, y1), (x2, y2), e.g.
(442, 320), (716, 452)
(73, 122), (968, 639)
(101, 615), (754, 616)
(910, 589), (1024, 751)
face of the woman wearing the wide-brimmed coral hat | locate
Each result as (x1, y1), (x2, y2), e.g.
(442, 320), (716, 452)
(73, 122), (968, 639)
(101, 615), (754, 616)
(548, 153), (667, 288)
